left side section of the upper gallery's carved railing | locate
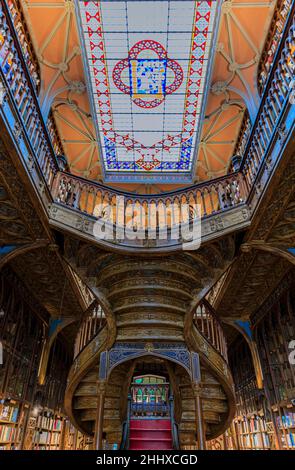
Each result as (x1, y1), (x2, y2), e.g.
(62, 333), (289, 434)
(0, 2), (58, 188)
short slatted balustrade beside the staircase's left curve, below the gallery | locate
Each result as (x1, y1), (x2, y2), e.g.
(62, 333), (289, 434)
(74, 301), (106, 359)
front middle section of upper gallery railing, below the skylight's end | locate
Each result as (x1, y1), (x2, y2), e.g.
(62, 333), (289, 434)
(53, 169), (246, 229)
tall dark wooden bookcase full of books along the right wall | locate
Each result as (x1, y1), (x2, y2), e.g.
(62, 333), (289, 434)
(225, 273), (295, 450)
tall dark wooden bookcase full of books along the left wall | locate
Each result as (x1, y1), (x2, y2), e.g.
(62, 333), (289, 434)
(0, 272), (81, 450)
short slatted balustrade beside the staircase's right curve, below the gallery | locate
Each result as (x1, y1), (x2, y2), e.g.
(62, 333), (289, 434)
(193, 299), (228, 362)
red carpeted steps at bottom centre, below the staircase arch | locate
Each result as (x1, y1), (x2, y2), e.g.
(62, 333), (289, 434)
(129, 419), (172, 450)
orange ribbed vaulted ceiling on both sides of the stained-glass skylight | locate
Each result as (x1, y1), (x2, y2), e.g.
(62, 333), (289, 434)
(21, 0), (276, 192)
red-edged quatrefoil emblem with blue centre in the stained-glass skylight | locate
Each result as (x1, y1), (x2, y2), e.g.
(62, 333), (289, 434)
(113, 39), (183, 109)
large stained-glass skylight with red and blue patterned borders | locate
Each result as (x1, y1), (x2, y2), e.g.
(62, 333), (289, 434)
(77, 0), (221, 183)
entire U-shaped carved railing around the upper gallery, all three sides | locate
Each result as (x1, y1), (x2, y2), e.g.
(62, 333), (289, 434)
(0, 2), (295, 248)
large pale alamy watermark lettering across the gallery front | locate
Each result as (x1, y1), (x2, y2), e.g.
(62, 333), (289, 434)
(93, 196), (201, 250)
